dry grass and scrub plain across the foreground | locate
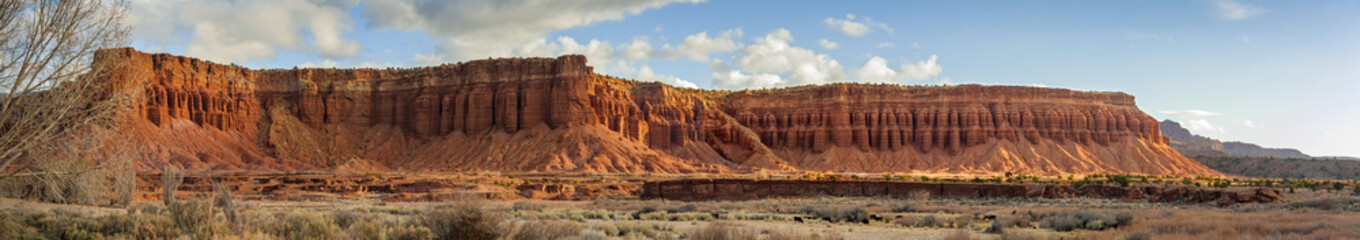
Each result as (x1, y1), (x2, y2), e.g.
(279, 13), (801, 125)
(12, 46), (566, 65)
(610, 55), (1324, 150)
(0, 190), (1360, 240)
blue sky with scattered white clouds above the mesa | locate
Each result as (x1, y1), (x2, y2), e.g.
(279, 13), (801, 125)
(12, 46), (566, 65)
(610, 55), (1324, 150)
(129, 0), (1360, 155)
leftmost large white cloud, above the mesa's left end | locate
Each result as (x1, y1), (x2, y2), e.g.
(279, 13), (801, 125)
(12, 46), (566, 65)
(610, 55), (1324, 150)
(128, 0), (362, 63)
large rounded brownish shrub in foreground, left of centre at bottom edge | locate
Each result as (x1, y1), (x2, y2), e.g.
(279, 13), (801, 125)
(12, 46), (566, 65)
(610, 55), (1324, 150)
(419, 200), (500, 240)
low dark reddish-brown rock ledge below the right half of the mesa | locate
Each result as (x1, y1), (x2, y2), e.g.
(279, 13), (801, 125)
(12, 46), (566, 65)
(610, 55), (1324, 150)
(641, 179), (1280, 206)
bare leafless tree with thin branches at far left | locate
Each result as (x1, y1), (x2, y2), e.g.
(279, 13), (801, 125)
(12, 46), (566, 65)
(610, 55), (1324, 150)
(0, 0), (143, 202)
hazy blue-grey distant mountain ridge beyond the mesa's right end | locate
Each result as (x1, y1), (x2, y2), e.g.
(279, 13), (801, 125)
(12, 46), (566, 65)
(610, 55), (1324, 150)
(1160, 120), (1312, 158)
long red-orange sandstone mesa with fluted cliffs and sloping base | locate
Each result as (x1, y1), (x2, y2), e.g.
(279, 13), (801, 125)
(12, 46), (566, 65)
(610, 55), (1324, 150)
(97, 49), (1219, 175)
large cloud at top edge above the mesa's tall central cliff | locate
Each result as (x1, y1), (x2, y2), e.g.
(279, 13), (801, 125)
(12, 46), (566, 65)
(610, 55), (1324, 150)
(363, 0), (702, 59)
